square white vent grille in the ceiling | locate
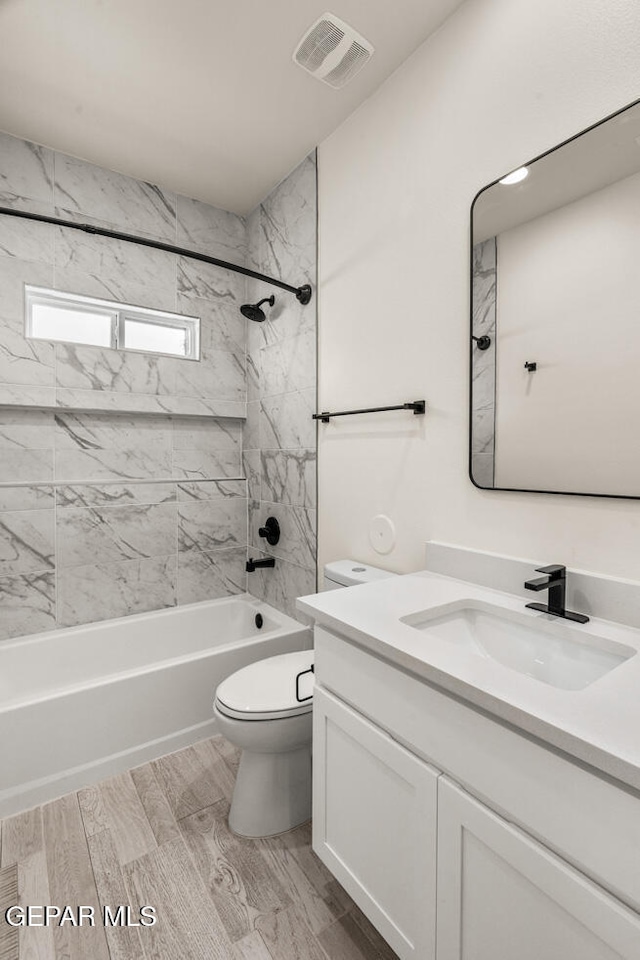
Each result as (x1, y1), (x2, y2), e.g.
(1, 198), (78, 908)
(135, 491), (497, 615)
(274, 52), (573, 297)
(293, 13), (374, 87)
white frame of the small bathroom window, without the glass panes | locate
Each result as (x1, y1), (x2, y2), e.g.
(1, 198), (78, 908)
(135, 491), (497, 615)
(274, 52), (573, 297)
(24, 284), (200, 361)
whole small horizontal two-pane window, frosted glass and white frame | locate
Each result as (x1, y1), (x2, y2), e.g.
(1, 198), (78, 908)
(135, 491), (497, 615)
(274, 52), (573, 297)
(25, 286), (200, 360)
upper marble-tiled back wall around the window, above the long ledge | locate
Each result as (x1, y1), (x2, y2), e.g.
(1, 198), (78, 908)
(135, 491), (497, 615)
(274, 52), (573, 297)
(0, 134), (246, 413)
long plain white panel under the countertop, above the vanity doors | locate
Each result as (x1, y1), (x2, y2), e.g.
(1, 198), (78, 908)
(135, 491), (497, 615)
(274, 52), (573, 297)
(315, 627), (640, 908)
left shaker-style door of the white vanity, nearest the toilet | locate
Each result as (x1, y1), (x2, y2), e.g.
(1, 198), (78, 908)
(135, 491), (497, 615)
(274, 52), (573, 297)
(313, 687), (438, 960)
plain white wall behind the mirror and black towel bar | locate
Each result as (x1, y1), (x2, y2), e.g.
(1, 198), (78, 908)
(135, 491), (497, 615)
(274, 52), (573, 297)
(319, 0), (640, 578)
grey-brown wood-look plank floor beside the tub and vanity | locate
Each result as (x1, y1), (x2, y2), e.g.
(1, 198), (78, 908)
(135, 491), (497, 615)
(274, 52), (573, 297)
(0, 737), (396, 960)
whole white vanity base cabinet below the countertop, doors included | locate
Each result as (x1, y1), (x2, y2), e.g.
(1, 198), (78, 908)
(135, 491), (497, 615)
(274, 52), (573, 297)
(313, 627), (640, 960)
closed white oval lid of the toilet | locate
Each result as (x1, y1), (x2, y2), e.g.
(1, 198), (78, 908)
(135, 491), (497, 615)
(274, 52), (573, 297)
(216, 650), (313, 719)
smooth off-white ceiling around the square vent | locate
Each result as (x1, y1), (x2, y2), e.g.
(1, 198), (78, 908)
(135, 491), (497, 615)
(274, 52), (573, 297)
(0, 0), (461, 214)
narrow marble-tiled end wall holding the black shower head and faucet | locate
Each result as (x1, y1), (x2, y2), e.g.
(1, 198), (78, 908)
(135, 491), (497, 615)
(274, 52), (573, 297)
(243, 155), (317, 618)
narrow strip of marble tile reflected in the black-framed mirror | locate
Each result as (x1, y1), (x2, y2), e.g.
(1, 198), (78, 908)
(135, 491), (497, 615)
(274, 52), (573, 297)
(471, 237), (497, 487)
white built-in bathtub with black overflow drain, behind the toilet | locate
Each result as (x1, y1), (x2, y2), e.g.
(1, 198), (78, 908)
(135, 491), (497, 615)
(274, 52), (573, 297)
(0, 594), (311, 817)
